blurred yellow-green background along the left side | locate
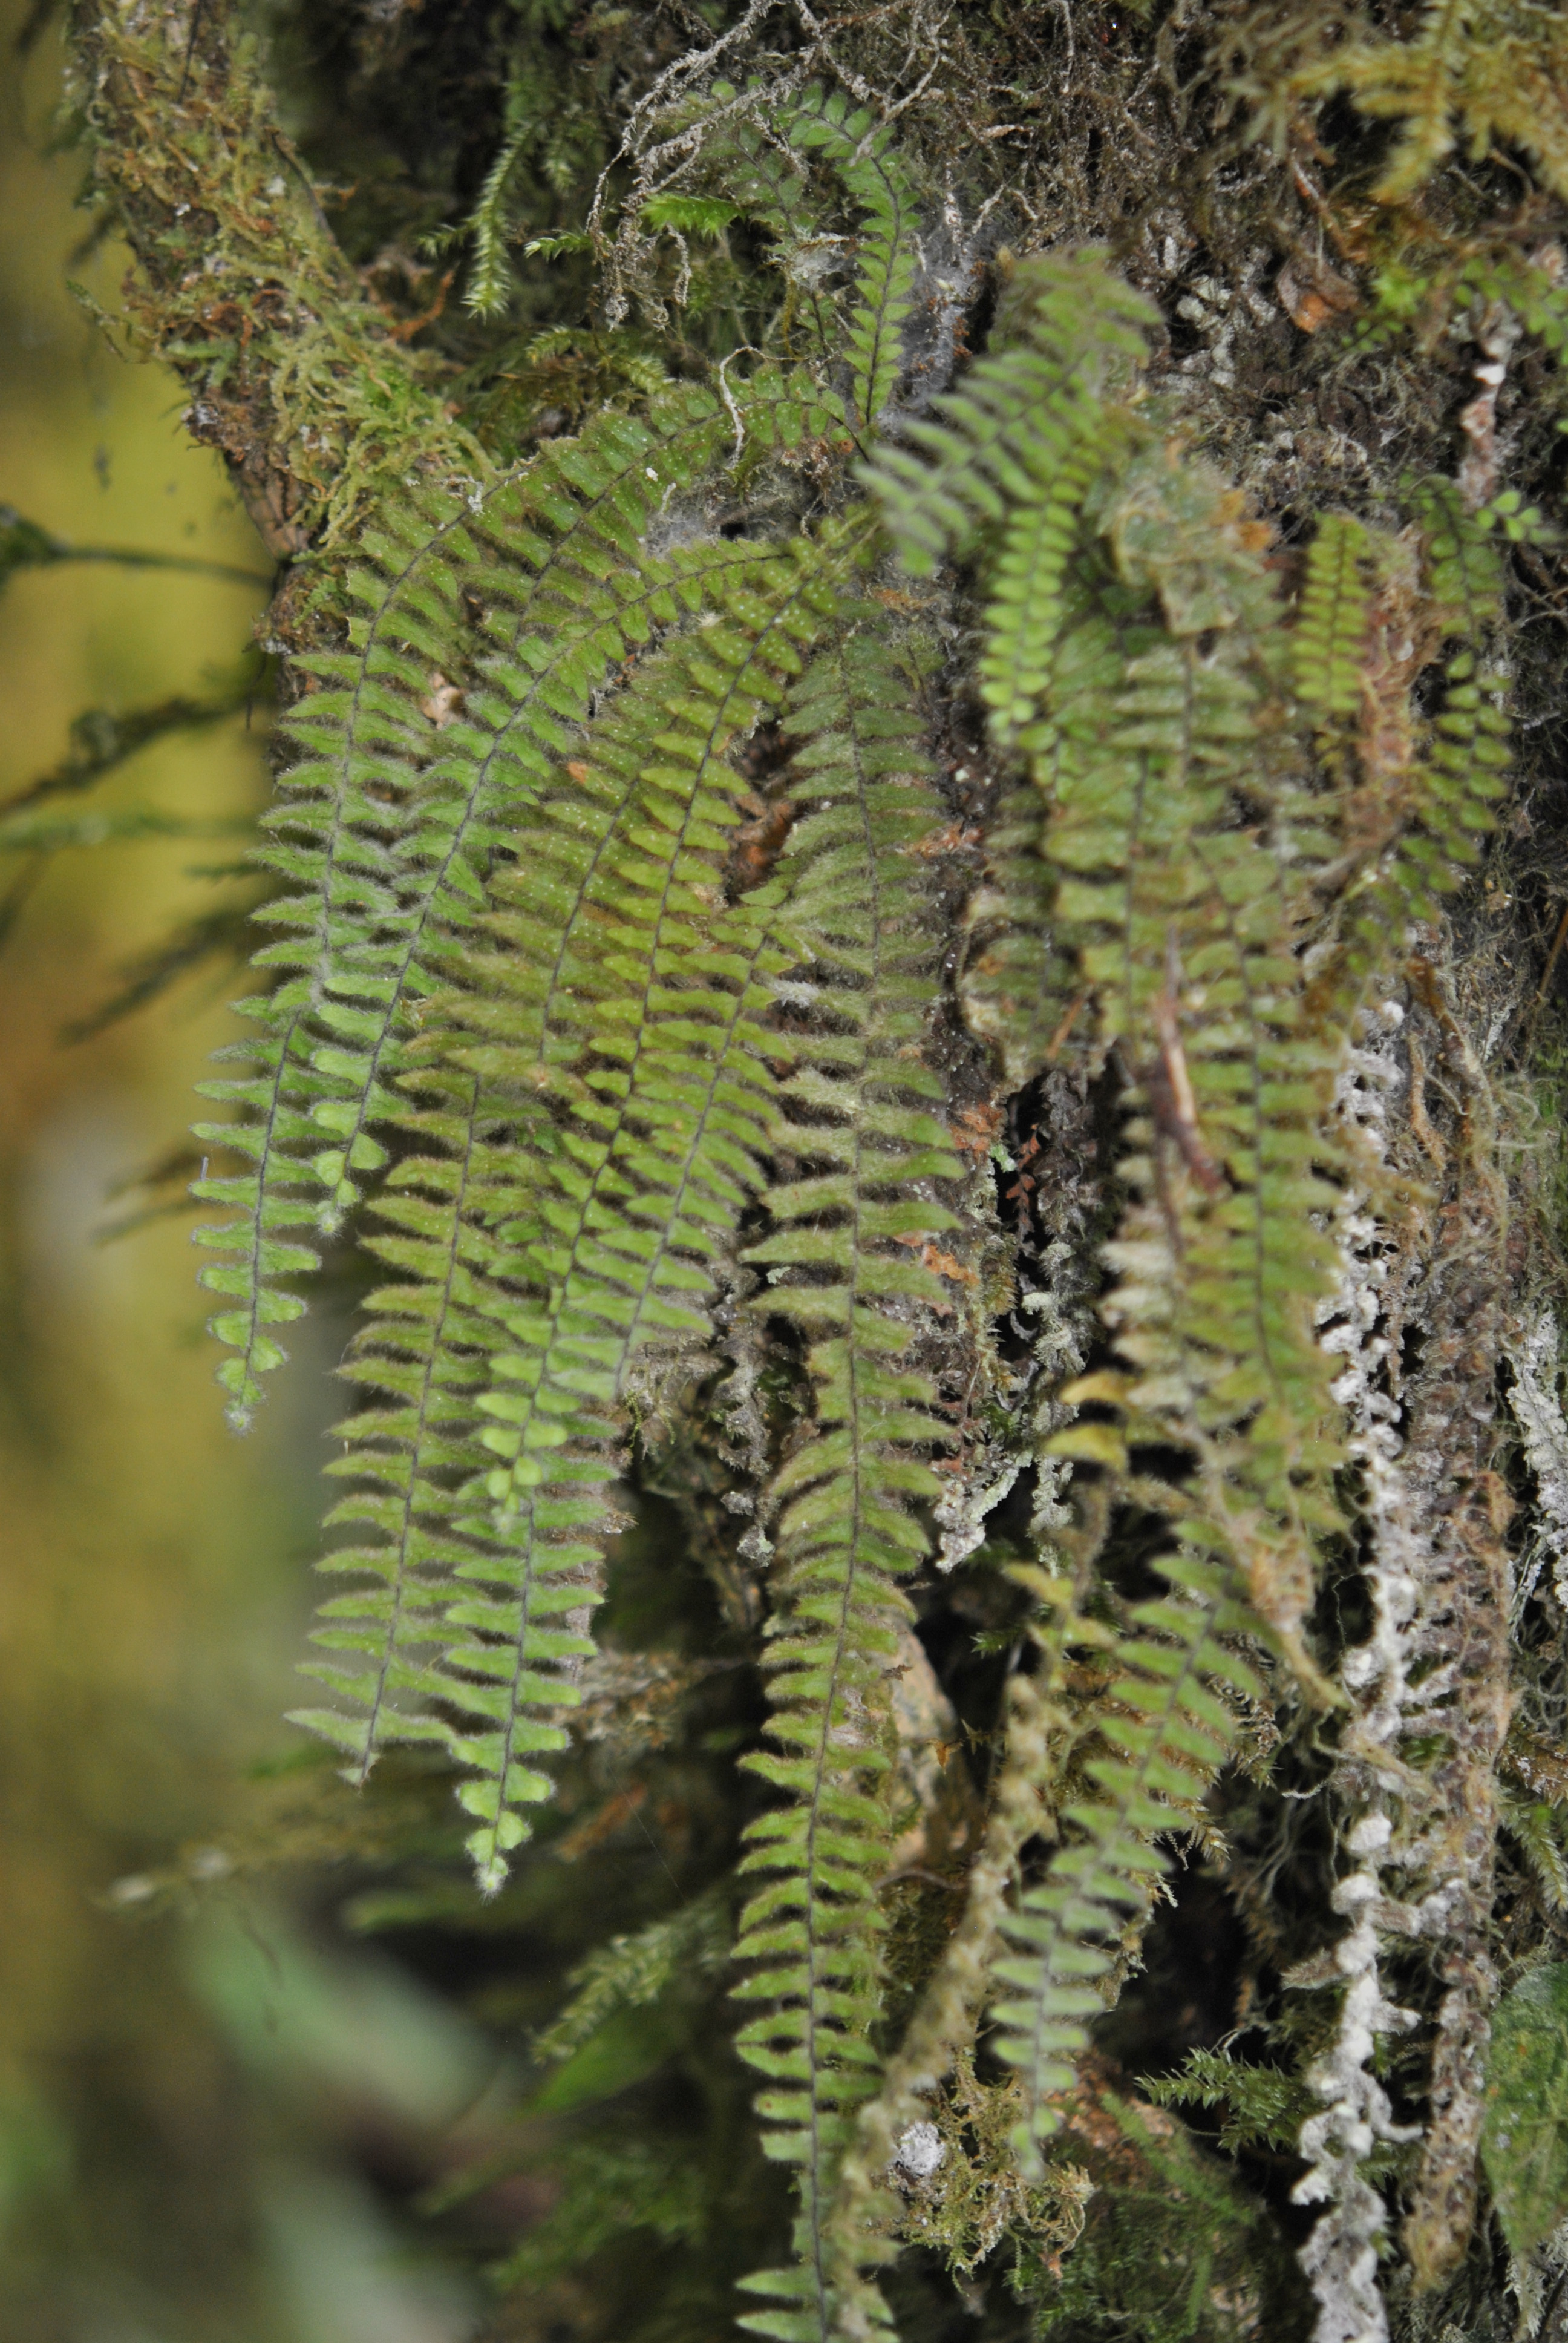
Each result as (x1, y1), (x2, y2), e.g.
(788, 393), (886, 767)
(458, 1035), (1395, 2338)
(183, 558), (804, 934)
(0, 0), (495, 2343)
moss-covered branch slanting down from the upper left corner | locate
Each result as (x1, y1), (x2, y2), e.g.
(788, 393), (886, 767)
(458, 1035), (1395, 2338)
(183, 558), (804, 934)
(70, 0), (490, 604)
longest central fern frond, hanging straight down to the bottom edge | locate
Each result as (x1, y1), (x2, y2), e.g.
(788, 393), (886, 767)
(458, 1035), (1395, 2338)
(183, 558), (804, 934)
(736, 612), (959, 2343)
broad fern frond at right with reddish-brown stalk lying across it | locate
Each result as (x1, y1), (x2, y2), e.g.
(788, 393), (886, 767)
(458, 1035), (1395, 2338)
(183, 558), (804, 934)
(1040, 448), (1341, 1677)
